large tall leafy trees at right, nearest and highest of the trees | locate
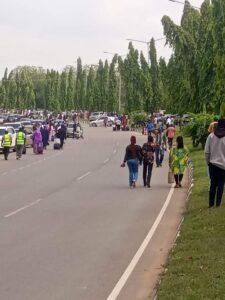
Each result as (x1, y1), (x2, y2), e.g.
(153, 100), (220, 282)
(159, 0), (225, 113)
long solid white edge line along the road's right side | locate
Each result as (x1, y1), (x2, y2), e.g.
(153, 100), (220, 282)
(107, 185), (174, 300)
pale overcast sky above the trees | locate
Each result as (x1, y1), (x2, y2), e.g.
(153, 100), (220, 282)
(0, 0), (202, 76)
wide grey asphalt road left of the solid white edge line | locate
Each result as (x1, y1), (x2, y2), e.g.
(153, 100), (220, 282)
(0, 128), (169, 300)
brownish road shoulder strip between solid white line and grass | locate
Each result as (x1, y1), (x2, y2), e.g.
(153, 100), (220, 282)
(118, 176), (188, 300)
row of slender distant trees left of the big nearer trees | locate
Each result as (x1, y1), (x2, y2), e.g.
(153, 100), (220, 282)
(0, 39), (160, 112)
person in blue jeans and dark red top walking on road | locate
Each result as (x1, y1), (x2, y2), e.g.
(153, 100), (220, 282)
(121, 136), (142, 188)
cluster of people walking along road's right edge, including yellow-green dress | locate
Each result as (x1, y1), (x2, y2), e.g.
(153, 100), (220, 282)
(121, 119), (189, 188)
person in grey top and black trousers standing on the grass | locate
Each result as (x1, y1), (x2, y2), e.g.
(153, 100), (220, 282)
(205, 119), (225, 207)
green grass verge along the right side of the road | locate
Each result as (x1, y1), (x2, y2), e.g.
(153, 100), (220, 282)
(158, 140), (225, 300)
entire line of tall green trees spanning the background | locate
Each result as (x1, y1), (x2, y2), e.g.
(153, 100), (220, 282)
(0, 0), (222, 113)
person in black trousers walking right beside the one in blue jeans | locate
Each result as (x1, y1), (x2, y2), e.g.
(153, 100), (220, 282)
(142, 135), (155, 188)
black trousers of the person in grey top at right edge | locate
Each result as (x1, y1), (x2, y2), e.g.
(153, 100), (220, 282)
(209, 164), (225, 207)
